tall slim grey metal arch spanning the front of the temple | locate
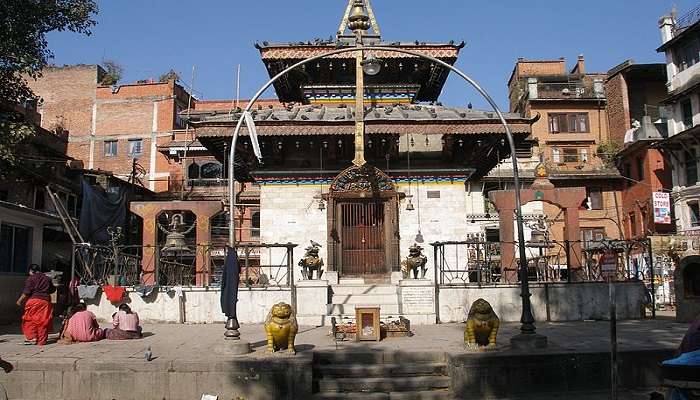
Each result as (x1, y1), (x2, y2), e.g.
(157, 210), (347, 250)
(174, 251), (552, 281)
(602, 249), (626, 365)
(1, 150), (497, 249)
(229, 46), (535, 333)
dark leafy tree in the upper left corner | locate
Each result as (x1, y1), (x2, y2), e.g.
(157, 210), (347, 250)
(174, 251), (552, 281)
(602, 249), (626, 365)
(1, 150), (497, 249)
(0, 0), (97, 169)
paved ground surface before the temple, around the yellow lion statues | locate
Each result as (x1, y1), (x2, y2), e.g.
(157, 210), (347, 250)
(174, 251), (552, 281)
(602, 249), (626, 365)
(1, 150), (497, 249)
(0, 316), (688, 363)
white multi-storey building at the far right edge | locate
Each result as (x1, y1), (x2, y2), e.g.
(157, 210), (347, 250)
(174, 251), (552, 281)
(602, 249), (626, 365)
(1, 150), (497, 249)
(657, 7), (700, 320)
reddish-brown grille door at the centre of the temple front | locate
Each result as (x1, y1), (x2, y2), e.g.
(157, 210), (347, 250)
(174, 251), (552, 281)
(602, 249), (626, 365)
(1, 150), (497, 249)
(340, 202), (387, 276)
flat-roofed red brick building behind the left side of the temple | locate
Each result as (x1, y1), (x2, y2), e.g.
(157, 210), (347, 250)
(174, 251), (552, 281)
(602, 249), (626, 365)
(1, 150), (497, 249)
(30, 65), (190, 192)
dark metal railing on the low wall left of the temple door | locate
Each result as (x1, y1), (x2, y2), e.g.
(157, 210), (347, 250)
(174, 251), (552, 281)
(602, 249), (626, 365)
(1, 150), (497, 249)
(72, 243), (297, 288)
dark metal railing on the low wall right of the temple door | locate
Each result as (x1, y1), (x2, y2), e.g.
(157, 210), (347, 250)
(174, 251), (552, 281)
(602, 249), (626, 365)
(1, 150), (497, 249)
(431, 240), (653, 286)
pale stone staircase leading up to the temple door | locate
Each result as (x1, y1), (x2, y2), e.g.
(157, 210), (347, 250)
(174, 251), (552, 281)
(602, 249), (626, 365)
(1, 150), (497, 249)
(327, 282), (401, 322)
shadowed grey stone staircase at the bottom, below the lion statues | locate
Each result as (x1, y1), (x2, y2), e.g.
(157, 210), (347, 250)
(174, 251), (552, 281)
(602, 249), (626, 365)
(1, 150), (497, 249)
(313, 350), (453, 400)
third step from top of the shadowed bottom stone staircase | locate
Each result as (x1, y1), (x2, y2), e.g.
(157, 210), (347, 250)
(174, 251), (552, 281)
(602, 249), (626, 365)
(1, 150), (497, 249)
(318, 376), (450, 393)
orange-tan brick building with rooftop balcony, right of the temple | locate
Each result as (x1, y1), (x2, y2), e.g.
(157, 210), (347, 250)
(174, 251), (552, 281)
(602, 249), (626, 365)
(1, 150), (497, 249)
(508, 56), (623, 247)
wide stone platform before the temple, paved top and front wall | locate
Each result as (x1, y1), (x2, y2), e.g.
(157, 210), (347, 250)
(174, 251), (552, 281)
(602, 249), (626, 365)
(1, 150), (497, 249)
(0, 318), (687, 400)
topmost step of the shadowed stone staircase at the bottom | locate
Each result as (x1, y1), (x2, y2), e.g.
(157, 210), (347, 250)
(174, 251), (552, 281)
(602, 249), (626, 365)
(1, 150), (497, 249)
(314, 350), (446, 366)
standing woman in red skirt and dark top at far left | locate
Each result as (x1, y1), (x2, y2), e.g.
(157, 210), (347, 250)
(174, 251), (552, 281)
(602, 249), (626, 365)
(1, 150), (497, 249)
(17, 264), (56, 346)
